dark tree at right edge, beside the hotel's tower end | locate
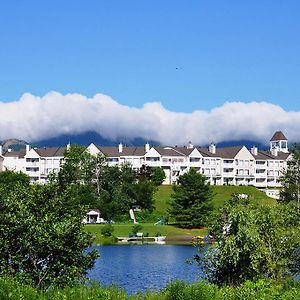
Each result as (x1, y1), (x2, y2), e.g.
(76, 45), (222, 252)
(279, 147), (300, 212)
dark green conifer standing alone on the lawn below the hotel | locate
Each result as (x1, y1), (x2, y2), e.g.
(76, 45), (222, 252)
(169, 169), (213, 228)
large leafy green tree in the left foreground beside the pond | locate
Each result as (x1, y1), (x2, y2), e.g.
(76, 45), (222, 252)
(0, 184), (97, 289)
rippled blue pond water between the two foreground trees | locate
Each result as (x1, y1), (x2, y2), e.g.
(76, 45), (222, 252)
(88, 245), (202, 294)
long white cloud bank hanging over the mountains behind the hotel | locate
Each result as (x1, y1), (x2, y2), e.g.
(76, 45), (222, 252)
(0, 92), (300, 145)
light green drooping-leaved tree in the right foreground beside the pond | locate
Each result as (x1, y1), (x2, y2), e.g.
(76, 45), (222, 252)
(195, 197), (300, 285)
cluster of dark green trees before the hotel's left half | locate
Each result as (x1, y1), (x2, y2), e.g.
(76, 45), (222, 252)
(56, 146), (165, 221)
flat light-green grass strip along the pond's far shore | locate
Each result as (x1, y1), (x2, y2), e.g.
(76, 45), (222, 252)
(85, 223), (207, 244)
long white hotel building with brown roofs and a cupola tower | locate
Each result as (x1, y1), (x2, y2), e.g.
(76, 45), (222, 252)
(0, 131), (290, 187)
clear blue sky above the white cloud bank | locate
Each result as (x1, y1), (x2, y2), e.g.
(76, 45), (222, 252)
(0, 0), (300, 112)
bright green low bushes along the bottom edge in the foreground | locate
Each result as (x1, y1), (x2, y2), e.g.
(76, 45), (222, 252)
(0, 278), (300, 300)
